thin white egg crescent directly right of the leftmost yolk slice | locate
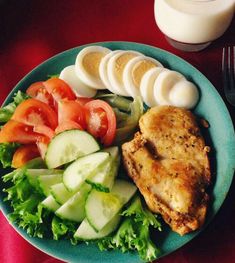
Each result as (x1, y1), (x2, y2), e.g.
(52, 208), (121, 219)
(99, 50), (120, 93)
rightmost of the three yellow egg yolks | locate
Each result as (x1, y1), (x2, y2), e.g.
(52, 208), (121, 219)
(132, 59), (157, 87)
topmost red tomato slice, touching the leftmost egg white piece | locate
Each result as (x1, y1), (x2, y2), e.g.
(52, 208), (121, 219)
(43, 78), (76, 102)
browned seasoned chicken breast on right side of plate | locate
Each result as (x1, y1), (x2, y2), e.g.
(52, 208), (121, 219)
(122, 106), (211, 235)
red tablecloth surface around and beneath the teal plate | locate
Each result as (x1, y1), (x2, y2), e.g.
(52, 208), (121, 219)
(0, 0), (235, 263)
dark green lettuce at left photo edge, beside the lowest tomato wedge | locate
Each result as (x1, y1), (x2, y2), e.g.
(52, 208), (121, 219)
(0, 142), (20, 168)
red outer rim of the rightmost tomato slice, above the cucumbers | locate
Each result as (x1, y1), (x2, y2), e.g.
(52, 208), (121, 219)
(85, 100), (116, 146)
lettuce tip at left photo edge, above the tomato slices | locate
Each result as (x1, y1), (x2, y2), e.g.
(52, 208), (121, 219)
(0, 90), (29, 122)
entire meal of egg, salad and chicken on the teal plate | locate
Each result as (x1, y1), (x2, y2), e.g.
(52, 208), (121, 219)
(0, 46), (210, 261)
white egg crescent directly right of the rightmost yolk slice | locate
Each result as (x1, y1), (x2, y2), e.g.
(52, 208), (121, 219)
(140, 67), (168, 107)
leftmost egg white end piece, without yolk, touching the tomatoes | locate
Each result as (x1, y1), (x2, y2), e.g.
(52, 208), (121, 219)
(59, 65), (97, 98)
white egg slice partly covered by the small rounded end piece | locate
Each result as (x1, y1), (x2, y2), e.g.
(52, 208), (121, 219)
(153, 70), (185, 105)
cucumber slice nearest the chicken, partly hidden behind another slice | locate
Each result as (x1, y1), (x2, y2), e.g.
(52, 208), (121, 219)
(86, 146), (120, 192)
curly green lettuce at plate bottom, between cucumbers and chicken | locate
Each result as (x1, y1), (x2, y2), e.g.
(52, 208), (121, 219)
(97, 195), (161, 262)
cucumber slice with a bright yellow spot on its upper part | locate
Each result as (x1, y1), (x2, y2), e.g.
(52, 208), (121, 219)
(85, 190), (122, 232)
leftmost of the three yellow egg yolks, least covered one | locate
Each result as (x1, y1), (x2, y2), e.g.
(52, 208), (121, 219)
(82, 52), (105, 78)
